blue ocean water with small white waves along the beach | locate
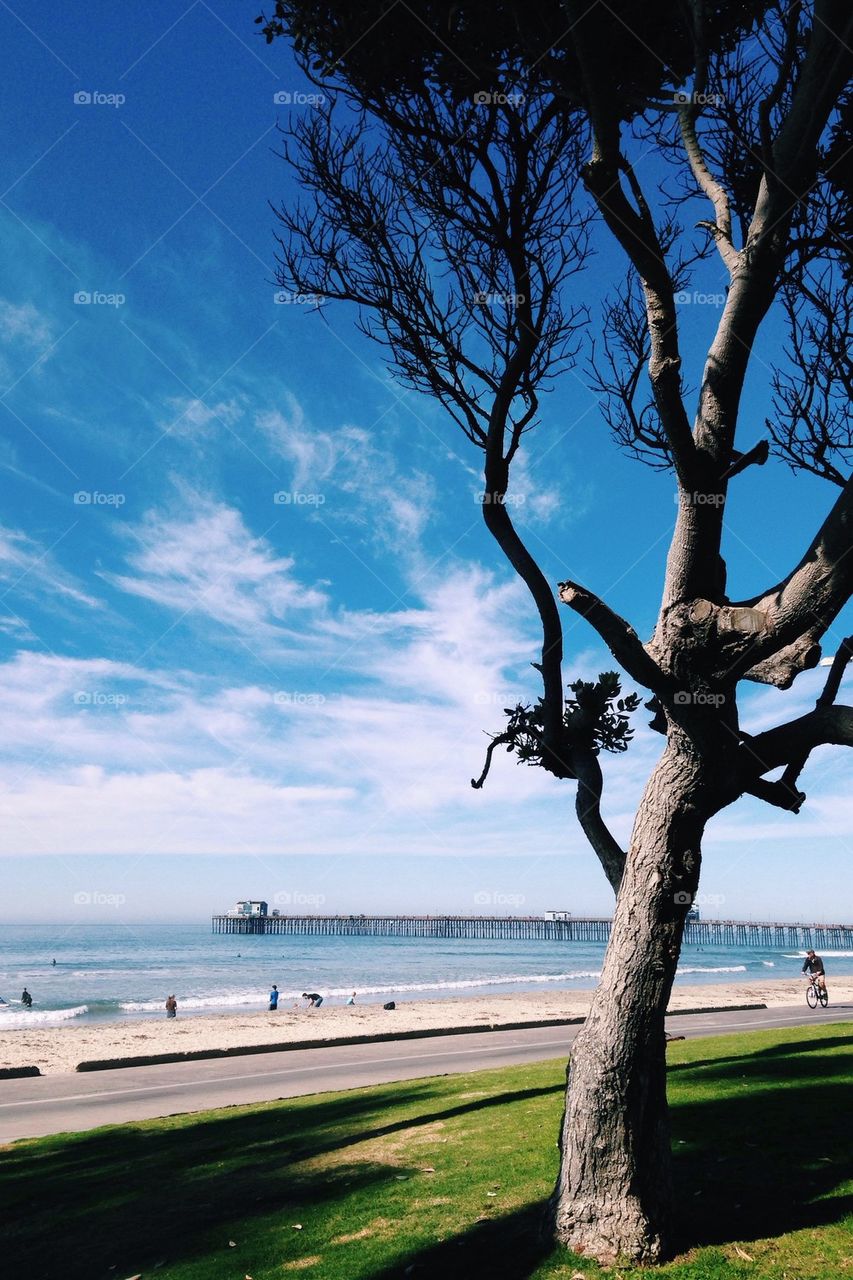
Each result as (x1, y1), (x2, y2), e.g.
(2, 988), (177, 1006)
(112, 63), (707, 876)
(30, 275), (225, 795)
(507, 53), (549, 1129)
(0, 923), (853, 1028)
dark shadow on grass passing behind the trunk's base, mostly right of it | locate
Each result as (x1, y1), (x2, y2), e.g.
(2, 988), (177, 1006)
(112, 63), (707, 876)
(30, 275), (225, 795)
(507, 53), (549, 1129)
(370, 1038), (853, 1280)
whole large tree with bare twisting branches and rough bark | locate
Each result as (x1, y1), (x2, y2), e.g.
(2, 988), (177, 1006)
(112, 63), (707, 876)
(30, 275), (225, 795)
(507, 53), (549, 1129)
(259, 0), (853, 1261)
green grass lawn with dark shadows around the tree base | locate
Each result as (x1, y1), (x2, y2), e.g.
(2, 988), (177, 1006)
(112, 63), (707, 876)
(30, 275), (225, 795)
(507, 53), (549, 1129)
(0, 1023), (853, 1280)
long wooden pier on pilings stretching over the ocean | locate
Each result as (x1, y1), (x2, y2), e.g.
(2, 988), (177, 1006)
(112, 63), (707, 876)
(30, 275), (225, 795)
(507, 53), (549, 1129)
(213, 915), (853, 951)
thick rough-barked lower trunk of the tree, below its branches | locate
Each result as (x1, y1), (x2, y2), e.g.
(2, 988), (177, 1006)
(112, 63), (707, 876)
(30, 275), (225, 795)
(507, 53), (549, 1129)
(551, 741), (713, 1262)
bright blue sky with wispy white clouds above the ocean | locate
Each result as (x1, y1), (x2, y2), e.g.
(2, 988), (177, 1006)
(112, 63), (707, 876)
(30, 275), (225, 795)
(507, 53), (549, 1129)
(0, 0), (853, 922)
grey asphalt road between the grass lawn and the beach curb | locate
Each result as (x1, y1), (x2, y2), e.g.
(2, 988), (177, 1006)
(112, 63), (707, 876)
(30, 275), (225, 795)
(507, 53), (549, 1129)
(0, 1005), (853, 1143)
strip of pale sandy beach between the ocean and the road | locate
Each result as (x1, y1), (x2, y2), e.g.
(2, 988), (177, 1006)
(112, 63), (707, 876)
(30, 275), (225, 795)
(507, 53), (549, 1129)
(0, 978), (853, 1075)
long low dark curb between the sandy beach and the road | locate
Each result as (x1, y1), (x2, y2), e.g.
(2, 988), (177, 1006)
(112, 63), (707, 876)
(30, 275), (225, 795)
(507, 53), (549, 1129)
(73, 1005), (767, 1074)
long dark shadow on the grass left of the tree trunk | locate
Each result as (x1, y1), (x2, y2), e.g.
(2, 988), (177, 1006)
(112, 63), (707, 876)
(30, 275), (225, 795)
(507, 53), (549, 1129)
(0, 1080), (562, 1280)
